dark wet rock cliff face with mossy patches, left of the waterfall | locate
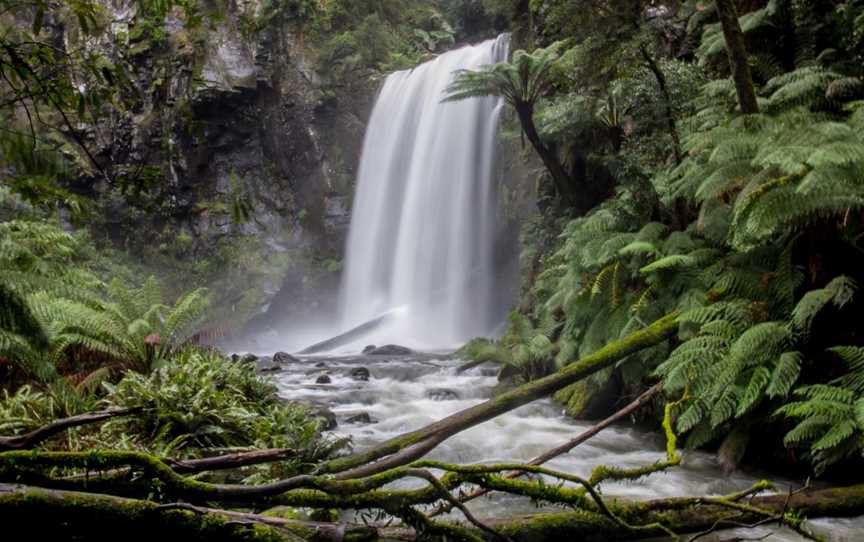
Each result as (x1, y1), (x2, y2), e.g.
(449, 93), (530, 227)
(64, 0), (377, 340)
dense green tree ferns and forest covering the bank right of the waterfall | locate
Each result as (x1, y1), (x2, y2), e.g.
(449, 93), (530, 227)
(462, 0), (864, 472)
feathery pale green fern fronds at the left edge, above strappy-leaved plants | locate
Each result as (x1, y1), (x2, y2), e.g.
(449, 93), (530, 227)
(0, 221), (208, 388)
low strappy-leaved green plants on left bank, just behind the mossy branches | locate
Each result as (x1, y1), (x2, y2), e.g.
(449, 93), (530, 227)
(96, 349), (346, 475)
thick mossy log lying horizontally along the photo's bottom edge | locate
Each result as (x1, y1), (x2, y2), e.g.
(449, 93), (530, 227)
(6, 484), (864, 542)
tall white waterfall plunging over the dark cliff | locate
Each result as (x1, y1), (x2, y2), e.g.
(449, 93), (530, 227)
(340, 35), (508, 347)
